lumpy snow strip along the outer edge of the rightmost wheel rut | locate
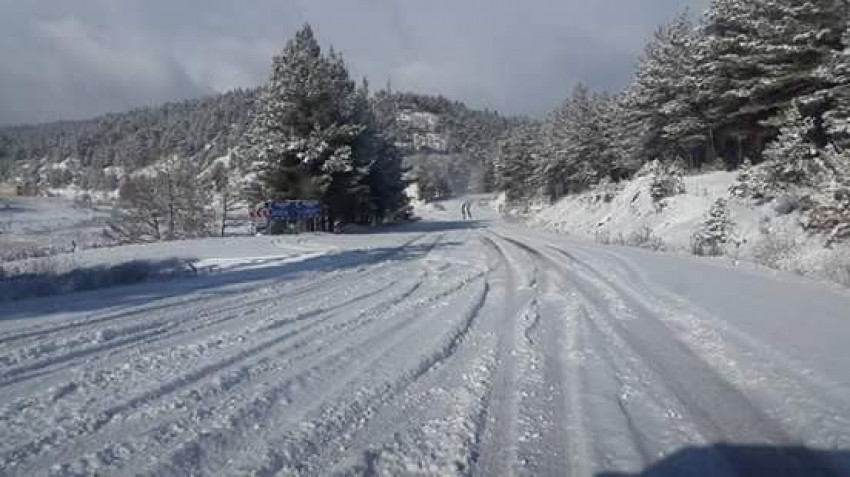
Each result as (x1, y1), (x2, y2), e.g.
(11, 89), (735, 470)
(548, 244), (850, 447)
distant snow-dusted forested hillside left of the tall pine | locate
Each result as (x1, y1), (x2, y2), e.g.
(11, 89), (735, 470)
(0, 89), (257, 190)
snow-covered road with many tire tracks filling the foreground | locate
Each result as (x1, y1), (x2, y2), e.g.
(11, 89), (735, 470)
(0, 205), (850, 476)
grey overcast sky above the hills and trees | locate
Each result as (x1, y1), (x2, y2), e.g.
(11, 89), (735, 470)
(0, 0), (708, 124)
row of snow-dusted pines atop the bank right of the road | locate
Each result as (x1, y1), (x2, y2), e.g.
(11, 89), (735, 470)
(495, 0), (850, 200)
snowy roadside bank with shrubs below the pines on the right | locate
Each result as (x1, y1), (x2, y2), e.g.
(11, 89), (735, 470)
(528, 172), (850, 284)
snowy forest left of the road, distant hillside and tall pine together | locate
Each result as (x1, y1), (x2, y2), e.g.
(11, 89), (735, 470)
(0, 25), (508, 241)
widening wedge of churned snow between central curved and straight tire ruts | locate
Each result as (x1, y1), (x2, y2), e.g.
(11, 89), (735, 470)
(290, 264), (499, 475)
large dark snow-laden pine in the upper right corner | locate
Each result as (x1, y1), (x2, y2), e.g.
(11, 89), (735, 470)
(697, 0), (850, 165)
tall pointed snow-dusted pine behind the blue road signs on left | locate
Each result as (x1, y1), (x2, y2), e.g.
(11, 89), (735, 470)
(238, 25), (372, 226)
